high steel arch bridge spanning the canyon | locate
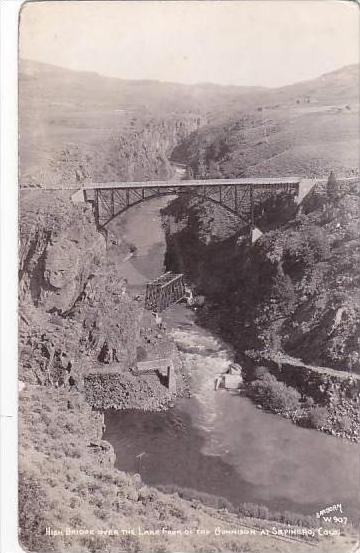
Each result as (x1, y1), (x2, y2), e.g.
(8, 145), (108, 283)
(73, 177), (316, 228)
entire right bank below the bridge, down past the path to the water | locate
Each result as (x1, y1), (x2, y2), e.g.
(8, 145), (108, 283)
(163, 180), (360, 441)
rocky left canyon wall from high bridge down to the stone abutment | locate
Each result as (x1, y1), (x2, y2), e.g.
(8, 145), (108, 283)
(19, 191), (181, 396)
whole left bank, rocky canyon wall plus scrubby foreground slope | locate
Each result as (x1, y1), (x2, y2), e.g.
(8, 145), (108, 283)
(19, 190), (344, 553)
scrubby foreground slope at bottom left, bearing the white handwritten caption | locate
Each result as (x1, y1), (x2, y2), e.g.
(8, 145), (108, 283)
(23, 385), (336, 553)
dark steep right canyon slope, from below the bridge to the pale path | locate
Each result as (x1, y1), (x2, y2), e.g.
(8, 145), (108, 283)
(163, 179), (360, 373)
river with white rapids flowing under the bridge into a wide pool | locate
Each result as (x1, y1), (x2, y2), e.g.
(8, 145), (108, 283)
(104, 198), (360, 517)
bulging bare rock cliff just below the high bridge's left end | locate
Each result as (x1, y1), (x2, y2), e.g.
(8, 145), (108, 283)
(19, 190), (105, 313)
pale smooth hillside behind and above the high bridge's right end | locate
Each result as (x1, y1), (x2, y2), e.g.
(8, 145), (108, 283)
(173, 66), (360, 178)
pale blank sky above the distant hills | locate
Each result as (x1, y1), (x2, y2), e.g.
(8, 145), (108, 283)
(19, 0), (360, 87)
